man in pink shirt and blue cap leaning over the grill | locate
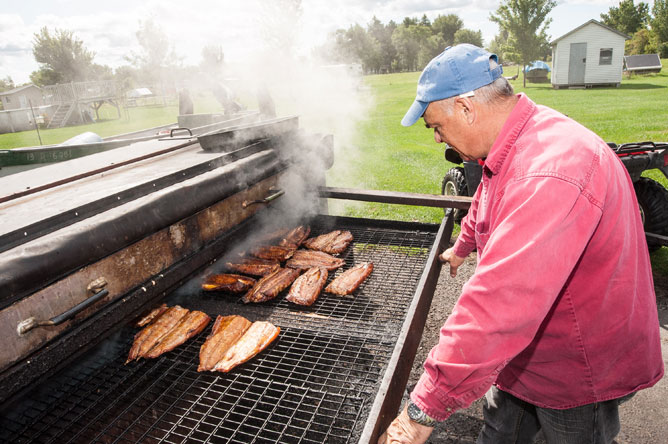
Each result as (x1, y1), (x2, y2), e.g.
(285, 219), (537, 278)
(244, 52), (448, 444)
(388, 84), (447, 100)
(378, 44), (663, 444)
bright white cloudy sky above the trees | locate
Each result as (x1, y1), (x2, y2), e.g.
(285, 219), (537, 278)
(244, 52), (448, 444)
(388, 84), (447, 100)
(0, 0), (640, 84)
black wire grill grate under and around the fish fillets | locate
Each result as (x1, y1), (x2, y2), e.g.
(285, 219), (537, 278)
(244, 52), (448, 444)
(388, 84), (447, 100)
(0, 218), (435, 443)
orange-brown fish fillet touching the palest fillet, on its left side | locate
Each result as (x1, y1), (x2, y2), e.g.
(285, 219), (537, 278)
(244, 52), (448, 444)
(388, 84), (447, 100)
(197, 315), (251, 372)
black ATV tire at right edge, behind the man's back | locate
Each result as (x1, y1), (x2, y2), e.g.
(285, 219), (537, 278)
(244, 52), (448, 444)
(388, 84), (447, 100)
(633, 177), (668, 251)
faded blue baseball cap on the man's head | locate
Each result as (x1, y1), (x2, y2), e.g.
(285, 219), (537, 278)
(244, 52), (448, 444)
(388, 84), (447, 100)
(401, 43), (503, 126)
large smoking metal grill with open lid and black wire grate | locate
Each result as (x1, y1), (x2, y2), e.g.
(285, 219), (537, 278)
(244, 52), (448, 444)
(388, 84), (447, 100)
(0, 116), (467, 443)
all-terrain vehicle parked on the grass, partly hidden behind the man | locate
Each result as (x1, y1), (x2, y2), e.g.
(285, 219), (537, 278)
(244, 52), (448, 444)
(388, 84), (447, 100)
(441, 142), (668, 251)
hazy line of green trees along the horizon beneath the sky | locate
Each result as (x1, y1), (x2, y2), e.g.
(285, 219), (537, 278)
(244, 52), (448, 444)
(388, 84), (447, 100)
(0, 0), (668, 96)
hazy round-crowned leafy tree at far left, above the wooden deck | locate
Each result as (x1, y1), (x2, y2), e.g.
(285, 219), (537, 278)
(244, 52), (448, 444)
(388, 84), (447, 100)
(30, 27), (94, 85)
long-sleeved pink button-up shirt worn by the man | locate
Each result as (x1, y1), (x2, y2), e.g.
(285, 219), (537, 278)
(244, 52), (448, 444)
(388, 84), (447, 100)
(411, 94), (663, 420)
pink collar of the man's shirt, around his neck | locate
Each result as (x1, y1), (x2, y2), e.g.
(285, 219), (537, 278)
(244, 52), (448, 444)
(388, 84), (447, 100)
(485, 93), (536, 174)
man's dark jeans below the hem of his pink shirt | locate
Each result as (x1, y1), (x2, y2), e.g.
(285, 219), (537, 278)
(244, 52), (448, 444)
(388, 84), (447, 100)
(476, 386), (632, 444)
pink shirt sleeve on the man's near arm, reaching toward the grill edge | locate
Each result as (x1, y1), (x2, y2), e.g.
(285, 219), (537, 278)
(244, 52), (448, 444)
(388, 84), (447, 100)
(411, 177), (601, 420)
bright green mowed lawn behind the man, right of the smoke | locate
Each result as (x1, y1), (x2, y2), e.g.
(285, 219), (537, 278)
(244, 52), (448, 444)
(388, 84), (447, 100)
(328, 60), (668, 274)
